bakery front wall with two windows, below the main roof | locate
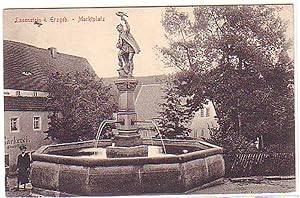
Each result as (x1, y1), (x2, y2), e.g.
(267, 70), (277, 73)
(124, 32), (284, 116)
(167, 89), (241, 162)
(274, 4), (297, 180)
(4, 89), (51, 170)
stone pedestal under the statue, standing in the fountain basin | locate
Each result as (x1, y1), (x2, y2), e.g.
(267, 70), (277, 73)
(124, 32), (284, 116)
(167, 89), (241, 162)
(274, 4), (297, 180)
(106, 78), (148, 158)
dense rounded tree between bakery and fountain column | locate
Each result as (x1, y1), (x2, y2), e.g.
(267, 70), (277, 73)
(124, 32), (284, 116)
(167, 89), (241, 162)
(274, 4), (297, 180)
(46, 70), (117, 142)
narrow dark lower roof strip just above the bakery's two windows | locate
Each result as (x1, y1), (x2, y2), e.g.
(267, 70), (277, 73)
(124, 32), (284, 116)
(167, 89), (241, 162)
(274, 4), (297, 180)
(4, 97), (47, 111)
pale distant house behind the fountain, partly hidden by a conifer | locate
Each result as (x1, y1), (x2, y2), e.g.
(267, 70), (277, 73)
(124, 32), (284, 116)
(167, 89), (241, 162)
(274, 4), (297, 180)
(135, 84), (219, 139)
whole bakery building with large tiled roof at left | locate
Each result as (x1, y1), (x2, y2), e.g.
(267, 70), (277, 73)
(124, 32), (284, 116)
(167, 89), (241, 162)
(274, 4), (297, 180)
(3, 40), (93, 169)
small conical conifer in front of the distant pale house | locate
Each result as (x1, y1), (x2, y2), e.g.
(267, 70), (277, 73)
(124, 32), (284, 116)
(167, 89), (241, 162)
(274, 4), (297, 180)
(158, 77), (190, 139)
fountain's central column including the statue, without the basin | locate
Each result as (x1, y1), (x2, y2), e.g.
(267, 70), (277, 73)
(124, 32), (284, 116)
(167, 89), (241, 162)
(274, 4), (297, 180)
(106, 12), (148, 158)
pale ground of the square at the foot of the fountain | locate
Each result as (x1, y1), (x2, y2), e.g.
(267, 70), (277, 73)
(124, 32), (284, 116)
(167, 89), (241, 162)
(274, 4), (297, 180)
(6, 178), (296, 197)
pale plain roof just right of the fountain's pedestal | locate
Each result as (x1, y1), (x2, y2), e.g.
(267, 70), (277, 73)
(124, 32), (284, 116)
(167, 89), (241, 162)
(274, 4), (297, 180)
(135, 84), (164, 120)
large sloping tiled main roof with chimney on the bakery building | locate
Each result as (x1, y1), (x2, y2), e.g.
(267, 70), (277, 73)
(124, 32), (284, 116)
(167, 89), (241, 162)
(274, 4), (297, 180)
(3, 40), (93, 91)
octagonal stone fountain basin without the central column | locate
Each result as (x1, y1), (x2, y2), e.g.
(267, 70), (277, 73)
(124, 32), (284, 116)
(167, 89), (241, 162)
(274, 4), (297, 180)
(31, 139), (225, 196)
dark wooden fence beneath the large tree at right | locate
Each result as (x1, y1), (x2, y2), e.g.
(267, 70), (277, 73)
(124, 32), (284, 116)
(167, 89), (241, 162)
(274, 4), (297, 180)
(224, 152), (295, 177)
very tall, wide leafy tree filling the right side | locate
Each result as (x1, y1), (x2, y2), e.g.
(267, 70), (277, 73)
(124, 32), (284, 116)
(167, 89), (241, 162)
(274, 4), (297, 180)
(160, 5), (294, 152)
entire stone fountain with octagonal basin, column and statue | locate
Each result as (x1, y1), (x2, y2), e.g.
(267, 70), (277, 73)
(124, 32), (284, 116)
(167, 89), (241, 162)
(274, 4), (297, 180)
(31, 12), (225, 196)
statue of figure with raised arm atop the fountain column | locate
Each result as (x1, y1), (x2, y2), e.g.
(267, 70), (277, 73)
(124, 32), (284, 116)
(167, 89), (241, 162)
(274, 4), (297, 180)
(116, 12), (140, 78)
